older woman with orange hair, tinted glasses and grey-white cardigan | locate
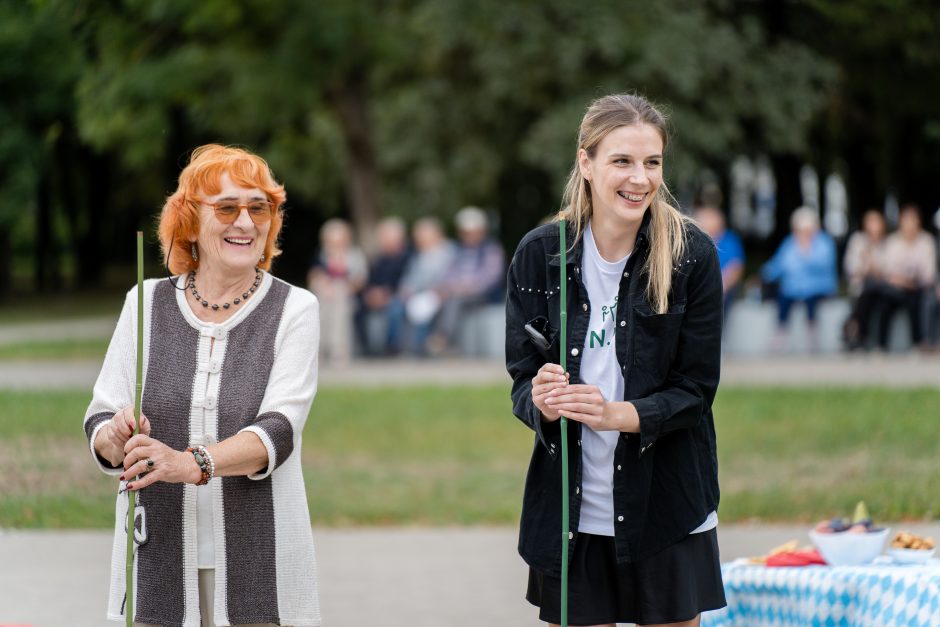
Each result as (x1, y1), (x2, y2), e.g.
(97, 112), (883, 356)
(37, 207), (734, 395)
(85, 145), (320, 627)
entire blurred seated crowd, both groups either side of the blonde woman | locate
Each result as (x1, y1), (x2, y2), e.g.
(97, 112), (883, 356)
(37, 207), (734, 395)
(307, 204), (940, 363)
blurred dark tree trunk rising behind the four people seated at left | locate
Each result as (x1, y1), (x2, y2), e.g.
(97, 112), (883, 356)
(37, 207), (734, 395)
(330, 77), (382, 250)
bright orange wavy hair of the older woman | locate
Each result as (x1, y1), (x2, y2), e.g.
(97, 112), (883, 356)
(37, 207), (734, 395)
(157, 144), (287, 274)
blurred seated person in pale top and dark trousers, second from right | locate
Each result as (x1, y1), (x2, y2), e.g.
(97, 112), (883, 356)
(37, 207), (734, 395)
(842, 209), (887, 350)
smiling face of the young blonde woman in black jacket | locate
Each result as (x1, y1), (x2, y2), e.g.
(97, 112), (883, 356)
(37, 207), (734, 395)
(578, 124), (663, 227)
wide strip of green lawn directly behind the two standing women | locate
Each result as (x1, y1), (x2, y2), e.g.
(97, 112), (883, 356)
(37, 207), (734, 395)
(0, 386), (940, 528)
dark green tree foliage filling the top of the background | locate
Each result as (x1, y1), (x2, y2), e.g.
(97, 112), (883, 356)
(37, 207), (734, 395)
(0, 0), (940, 288)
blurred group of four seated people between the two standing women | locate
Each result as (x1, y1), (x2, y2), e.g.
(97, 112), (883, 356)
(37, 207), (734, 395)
(307, 207), (506, 363)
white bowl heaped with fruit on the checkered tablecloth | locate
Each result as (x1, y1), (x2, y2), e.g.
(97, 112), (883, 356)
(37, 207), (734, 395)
(809, 502), (890, 566)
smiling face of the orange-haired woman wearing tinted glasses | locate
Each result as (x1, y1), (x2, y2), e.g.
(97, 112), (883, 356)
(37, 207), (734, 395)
(196, 172), (271, 274)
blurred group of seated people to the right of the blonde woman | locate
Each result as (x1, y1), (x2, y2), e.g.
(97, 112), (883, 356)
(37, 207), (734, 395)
(695, 204), (940, 353)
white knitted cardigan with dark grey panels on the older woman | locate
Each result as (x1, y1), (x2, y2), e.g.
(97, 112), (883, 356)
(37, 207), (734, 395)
(84, 273), (320, 627)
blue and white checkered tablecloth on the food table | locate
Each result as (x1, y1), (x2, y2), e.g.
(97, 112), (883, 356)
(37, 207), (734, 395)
(702, 560), (940, 627)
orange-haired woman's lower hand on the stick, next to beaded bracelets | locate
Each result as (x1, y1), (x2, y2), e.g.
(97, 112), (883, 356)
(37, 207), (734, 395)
(121, 434), (202, 490)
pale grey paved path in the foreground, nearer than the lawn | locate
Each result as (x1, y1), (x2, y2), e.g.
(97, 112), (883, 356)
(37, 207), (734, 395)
(0, 524), (940, 627)
